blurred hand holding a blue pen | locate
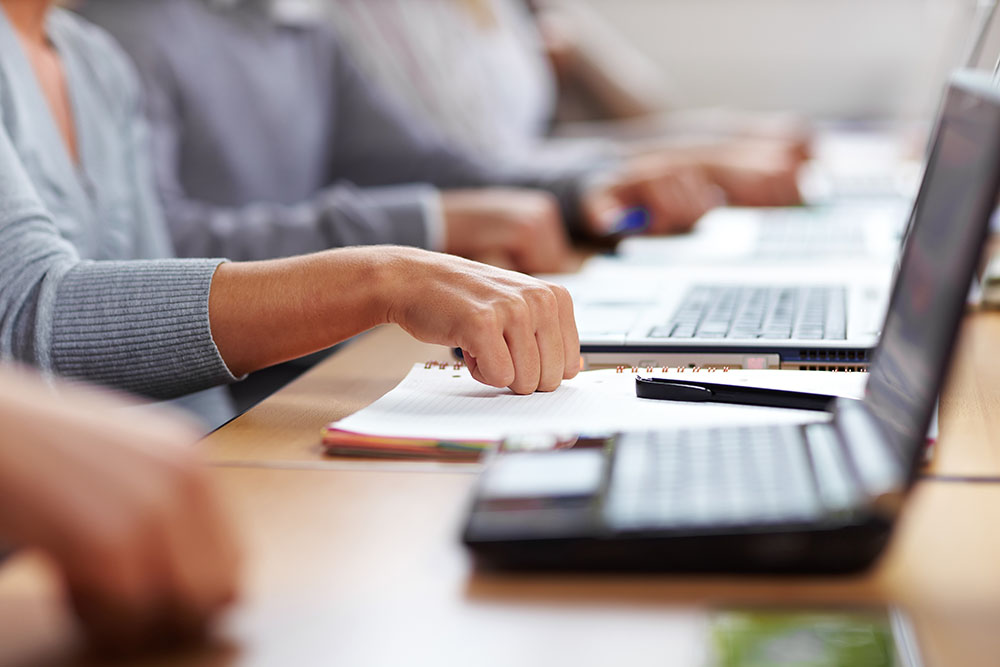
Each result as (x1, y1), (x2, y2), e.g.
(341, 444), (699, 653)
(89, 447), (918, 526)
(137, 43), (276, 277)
(582, 157), (722, 236)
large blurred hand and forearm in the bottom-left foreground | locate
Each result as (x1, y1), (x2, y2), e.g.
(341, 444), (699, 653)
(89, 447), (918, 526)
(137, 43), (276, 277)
(0, 368), (240, 652)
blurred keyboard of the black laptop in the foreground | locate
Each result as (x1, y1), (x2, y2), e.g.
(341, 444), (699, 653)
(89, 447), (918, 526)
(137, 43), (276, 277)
(605, 424), (828, 530)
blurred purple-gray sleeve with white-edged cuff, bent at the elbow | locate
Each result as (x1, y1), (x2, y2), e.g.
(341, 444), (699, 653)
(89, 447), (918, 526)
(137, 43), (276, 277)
(131, 39), (433, 260)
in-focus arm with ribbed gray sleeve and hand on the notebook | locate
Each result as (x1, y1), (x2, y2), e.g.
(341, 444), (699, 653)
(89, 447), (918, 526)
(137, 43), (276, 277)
(0, 107), (579, 398)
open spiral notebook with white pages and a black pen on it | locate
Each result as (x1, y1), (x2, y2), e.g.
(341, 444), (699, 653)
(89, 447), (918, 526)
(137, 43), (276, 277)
(323, 362), (867, 461)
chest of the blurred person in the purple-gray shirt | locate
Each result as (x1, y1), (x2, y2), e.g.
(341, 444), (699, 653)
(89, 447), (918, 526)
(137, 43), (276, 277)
(168, 17), (337, 206)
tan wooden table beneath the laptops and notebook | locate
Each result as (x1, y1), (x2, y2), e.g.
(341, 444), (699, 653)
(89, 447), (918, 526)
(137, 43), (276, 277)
(0, 313), (1000, 666)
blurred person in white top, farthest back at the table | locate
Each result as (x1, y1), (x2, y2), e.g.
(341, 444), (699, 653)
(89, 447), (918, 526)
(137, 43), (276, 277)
(320, 0), (804, 206)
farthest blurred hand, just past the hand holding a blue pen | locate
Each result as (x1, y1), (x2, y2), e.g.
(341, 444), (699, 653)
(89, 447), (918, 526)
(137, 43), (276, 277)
(704, 141), (802, 206)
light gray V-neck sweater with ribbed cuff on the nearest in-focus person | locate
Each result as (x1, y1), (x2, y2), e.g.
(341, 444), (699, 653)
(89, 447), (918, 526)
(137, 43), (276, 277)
(0, 10), (234, 421)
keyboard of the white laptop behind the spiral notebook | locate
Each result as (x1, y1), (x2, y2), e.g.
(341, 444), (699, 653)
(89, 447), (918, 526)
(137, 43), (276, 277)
(649, 286), (847, 340)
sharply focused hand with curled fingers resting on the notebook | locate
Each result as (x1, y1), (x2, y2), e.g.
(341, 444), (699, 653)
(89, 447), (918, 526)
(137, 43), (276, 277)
(380, 248), (580, 394)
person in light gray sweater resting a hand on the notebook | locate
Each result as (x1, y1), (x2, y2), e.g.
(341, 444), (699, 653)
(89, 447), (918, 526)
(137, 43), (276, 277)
(0, 0), (579, 423)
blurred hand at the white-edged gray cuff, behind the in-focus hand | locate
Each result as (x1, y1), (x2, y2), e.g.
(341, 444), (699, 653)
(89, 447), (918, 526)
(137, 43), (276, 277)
(441, 188), (570, 273)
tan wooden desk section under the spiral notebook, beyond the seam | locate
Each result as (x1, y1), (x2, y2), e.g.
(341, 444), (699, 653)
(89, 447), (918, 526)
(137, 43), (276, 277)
(205, 313), (1000, 476)
